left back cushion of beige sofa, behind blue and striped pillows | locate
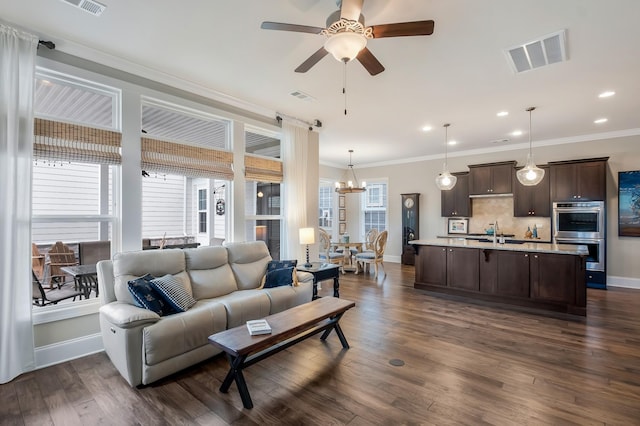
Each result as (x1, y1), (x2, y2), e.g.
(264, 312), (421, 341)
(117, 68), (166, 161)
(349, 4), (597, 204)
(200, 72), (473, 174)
(113, 249), (191, 305)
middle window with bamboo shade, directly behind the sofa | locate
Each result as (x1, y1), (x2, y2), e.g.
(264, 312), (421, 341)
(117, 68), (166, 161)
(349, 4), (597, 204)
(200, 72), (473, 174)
(141, 98), (233, 247)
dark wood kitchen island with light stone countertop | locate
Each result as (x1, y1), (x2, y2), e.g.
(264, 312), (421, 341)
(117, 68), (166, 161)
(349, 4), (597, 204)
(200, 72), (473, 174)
(410, 238), (588, 316)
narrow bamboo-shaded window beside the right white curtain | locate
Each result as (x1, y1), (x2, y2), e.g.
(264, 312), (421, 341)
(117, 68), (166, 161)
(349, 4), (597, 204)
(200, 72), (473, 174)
(245, 128), (284, 260)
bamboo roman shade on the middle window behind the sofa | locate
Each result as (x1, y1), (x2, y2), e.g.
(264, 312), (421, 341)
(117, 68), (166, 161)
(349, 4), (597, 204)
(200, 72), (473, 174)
(142, 138), (233, 180)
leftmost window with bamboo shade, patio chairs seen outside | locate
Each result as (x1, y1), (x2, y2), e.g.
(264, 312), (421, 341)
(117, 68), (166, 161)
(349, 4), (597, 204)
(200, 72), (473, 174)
(31, 68), (120, 312)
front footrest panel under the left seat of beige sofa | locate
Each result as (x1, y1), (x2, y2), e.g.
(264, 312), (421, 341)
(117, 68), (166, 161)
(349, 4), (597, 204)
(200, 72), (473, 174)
(138, 302), (227, 365)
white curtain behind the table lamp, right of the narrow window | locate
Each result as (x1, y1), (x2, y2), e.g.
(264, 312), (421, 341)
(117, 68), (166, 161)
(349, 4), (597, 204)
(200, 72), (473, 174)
(281, 119), (310, 262)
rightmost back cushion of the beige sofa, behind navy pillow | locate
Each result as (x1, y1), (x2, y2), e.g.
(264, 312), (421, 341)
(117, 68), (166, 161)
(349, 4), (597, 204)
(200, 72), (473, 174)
(225, 241), (271, 290)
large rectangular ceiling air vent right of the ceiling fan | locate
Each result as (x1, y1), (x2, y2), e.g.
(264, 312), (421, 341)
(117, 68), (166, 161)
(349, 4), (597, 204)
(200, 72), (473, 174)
(506, 30), (567, 73)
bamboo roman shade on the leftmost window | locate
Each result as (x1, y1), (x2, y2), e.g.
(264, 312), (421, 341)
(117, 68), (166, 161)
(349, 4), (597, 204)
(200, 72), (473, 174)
(33, 118), (122, 164)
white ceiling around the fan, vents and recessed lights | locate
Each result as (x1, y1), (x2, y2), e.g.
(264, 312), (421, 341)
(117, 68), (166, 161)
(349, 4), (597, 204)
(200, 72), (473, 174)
(0, 0), (640, 166)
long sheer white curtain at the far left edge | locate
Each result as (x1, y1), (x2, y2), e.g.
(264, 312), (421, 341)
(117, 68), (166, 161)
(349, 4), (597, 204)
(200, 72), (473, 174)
(0, 23), (38, 383)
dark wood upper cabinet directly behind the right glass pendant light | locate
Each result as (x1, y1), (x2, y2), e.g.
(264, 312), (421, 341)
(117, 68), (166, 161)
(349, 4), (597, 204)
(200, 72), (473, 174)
(513, 166), (551, 217)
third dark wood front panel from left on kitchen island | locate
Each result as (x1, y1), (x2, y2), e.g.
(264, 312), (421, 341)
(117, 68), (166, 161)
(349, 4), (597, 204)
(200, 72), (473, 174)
(480, 249), (530, 298)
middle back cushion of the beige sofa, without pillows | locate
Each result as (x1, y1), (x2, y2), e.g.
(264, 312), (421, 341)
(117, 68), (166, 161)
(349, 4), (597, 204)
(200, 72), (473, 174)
(184, 246), (238, 300)
